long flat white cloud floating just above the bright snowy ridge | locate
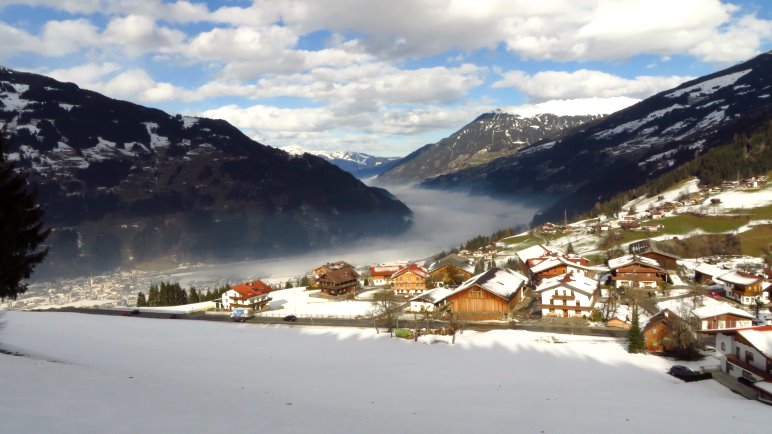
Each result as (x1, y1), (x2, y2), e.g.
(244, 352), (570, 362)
(492, 69), (694, 102)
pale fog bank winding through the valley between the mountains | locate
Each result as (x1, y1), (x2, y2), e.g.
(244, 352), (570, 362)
(171, 186), (549, 285)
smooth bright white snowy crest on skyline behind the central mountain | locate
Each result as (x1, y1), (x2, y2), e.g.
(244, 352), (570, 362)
(502, 96), (640, 116)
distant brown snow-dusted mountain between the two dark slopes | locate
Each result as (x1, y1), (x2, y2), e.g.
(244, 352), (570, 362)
(377, 111), (599, 184)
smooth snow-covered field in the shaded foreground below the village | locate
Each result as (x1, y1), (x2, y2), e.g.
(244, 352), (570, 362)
(0, 312), (770, 434)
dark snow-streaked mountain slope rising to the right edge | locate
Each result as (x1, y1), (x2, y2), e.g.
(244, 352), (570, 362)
(422, 52), (772, 222)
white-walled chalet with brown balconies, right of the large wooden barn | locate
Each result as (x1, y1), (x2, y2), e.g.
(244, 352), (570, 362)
(534, 272), (600, 318)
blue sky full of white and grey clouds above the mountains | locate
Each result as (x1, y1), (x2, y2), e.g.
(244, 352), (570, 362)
(0, 0), (772, 156)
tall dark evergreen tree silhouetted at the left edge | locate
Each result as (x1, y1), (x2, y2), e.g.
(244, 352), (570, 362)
(0, 137), (50, 300)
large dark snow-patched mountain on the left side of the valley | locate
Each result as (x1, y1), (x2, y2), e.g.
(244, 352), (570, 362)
(0, 69), (412, 274)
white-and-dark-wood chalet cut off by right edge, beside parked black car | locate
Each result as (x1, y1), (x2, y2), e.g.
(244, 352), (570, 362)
(716, 326), (772, 404)
